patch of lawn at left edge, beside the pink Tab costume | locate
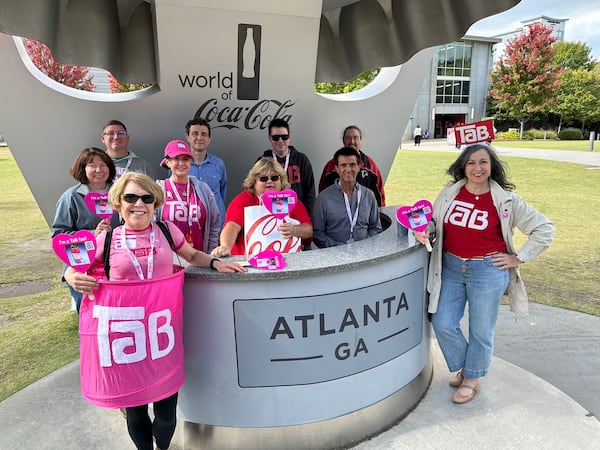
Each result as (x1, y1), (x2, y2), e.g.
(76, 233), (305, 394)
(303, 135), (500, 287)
(0, 152), (79, 401)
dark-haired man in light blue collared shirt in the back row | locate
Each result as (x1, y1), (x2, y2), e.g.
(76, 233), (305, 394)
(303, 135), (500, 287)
(185, 117), (227, 227)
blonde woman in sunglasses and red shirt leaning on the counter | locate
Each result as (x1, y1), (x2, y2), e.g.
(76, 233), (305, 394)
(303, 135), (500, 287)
(211, 157), (312, 257)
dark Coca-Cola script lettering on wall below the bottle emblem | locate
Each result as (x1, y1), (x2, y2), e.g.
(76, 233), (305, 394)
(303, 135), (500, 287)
(194, 98), (296, 130)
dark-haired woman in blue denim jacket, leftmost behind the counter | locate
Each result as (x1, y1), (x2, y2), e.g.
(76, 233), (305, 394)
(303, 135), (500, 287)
(52, 147), (118, 312)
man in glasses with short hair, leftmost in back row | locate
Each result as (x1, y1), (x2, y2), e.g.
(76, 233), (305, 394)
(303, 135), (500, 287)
(100, 120), (156, 181)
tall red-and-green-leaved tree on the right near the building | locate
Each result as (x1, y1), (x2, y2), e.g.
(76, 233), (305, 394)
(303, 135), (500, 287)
(488, 23), (563, 139)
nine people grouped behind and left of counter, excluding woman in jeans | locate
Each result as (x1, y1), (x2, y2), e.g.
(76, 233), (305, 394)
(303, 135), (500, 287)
(52, 118), (385, 449)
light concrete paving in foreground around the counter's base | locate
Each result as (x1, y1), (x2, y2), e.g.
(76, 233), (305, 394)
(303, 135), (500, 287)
(0, 303), (600, 450)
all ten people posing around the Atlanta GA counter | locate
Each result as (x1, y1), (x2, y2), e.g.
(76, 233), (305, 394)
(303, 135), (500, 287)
(52, 118), (554, 449)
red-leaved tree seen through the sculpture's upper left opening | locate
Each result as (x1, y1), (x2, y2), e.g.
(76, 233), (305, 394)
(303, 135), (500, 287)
(23, 39), (94, 91)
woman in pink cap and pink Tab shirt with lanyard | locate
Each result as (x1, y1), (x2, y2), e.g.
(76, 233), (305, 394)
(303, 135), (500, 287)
(156, 140), (221, 253)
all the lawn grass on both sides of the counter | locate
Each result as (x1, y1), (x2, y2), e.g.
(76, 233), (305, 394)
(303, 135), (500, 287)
(0, 141), (600, 400)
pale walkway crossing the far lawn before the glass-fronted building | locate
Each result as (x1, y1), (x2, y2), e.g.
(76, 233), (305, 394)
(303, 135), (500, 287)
(401, 139), (600, 168)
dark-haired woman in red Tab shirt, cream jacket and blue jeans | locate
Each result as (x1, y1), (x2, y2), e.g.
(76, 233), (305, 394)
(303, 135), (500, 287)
(415, 144), (554, 403)
